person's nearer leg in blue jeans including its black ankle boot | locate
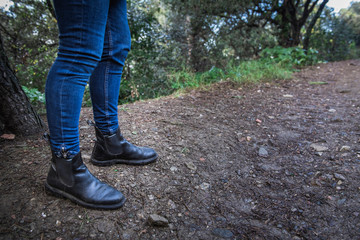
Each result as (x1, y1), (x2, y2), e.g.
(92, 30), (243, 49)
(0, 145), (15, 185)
(45, 0), (125, 209)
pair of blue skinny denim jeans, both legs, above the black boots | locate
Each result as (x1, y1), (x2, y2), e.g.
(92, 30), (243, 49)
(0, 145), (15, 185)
(45, 0), (131, 157)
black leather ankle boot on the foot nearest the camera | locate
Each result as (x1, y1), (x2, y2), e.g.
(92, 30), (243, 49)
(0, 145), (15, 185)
(45, 152), (126, 209)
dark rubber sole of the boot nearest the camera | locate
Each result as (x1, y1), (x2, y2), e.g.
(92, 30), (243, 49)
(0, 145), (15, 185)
(45, 182), (126, 210)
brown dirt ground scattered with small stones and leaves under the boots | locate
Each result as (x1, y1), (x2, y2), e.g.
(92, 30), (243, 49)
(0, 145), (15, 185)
(0, 60), (360, 240)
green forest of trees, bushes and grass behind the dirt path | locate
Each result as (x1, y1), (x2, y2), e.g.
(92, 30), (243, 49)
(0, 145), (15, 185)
(0, 0), (360, 113)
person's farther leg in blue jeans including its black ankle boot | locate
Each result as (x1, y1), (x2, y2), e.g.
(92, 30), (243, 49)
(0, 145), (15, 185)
(90, 0), (158, 165)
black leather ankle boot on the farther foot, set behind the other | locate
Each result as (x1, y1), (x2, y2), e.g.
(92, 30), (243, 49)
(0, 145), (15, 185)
(90, 126), (158, 166)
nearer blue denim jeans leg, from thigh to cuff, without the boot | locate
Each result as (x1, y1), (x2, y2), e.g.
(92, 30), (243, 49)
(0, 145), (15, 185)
(46, 0), (109, 155)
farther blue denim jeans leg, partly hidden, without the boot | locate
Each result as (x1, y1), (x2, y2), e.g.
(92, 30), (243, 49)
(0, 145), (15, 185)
(89, 0), (131, 135)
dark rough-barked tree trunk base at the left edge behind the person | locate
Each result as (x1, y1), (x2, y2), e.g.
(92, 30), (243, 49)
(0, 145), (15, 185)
(0, 31), (44, 136)
